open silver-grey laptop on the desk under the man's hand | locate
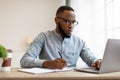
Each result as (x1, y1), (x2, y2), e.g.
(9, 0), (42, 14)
(75, 39), (120, 74)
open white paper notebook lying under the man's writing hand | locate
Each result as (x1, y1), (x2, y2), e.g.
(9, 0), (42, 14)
(18, 67), (73, 74)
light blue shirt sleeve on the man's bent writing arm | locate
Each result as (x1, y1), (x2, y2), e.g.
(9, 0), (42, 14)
(20, 33), (45, 68)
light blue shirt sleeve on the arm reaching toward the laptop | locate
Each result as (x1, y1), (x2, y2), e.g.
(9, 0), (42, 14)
(80, 42), (97, 66)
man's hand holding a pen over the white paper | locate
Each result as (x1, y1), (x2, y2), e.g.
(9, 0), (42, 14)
(42, 58), (67, 69)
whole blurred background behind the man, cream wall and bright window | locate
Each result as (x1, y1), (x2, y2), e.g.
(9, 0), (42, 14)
(0, 0), (120, 67)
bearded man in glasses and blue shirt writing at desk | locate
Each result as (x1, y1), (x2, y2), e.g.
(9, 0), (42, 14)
(20, 6), (101, 69)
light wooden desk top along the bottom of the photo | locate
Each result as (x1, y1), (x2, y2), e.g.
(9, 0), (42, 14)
(0, 68), (120, 80)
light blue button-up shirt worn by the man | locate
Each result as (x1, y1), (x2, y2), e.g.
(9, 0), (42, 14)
(20, 30), (96, 67)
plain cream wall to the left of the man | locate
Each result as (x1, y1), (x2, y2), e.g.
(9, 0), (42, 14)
(0, 0), (65, 67)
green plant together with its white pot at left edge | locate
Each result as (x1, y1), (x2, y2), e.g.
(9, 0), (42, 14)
(0, 45), (8, 69)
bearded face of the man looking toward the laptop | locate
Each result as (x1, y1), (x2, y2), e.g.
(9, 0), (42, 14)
(57, 10), (75, 38)
